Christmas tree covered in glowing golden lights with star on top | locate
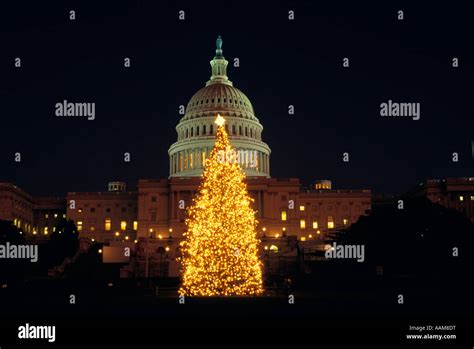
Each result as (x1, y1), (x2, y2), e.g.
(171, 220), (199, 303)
(179, 115), (263, 296)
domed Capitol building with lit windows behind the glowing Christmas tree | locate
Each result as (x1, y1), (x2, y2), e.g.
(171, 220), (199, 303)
(0, 37), (380, 276)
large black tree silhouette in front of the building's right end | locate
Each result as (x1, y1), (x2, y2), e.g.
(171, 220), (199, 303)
(337, 198), (474, 276)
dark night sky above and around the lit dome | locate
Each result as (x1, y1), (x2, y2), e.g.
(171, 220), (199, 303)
(0, 0), (474, 195)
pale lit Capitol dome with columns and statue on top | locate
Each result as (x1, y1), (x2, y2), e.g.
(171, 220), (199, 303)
(168, 36), (271, 177)
